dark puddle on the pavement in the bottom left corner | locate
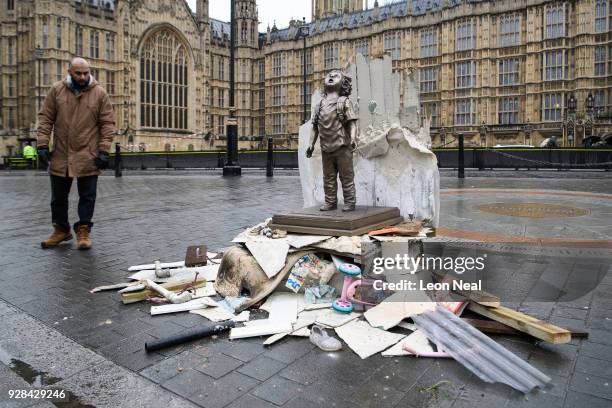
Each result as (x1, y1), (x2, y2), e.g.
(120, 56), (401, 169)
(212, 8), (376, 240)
(0, 348), (96, 408)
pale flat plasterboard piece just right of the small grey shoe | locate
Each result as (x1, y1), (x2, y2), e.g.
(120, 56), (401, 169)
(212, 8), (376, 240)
(335, 320), (406, 359)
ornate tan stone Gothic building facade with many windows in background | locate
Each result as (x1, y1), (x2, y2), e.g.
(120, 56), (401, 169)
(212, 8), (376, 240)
(0, 0), (612, 155)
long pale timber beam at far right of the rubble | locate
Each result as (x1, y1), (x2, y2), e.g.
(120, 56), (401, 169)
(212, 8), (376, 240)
(468, 302), (572, 344)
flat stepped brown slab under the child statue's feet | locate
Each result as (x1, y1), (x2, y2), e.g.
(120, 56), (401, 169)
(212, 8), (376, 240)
(272, 205), (400, 230)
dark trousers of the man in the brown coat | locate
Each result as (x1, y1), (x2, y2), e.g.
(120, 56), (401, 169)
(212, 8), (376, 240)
(51, 175), (98, 230)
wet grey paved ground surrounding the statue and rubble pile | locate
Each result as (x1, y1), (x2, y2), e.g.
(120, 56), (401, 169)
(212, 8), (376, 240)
(0, 171), (612, 407)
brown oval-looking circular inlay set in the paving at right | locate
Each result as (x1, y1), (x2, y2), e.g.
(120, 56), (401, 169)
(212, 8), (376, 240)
(477, 203), (589, 218)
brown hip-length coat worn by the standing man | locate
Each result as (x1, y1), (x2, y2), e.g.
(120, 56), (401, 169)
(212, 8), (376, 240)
(37, 76), (116, 177)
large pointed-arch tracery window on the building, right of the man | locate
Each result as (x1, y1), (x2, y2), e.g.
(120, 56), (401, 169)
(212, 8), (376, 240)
(140, 29), (189, 129)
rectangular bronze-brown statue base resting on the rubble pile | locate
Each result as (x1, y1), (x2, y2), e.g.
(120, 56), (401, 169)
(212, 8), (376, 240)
(270, 205), (403, 236)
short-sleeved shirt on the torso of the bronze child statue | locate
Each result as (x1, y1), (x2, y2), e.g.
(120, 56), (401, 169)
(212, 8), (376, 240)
(313, 96), (358, 153)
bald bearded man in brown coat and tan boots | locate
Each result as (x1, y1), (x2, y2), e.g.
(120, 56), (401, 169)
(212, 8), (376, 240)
(37, 58), (115, 249)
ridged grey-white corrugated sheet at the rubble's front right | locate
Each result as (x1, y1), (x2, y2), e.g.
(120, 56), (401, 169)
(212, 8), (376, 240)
(412, 306), (550, 394)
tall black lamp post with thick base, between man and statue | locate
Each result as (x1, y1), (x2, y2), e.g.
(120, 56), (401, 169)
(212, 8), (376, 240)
(223, 0), (242, 176)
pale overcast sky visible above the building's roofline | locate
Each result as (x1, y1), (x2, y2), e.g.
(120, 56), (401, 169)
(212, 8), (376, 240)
(187, 0), (389, 33)
